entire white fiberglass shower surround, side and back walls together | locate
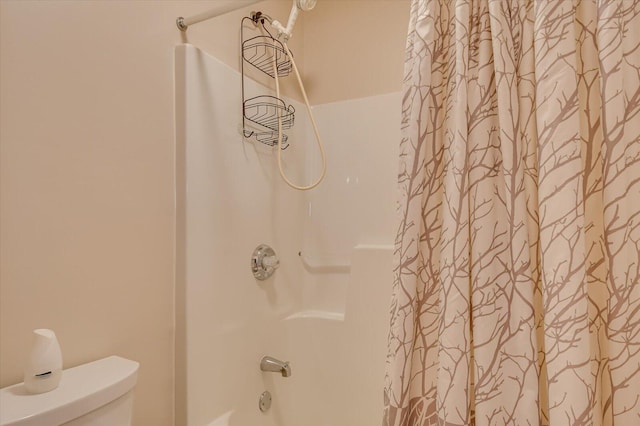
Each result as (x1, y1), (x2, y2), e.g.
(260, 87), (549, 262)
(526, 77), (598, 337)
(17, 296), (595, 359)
(176, 45), (400, 426)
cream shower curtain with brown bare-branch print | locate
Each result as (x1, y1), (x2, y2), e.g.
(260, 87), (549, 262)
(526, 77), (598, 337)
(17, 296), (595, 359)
(384, 0), (640, 426)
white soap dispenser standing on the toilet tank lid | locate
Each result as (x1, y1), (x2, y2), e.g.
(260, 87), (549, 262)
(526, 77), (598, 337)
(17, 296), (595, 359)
(24, 328), (62, 393)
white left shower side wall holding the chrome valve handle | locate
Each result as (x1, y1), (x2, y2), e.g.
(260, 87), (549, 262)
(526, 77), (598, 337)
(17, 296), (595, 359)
(176, 45), (305, 425)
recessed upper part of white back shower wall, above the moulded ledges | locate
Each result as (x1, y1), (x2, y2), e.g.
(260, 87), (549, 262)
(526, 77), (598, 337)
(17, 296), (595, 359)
(302, 93), (401, 312)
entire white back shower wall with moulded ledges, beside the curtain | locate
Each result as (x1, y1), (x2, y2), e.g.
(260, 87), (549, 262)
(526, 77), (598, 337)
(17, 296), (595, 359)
(284, 93), (401, 426)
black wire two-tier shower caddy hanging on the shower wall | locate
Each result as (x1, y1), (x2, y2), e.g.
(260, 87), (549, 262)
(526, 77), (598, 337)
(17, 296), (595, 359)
(240, 12), (295, 149)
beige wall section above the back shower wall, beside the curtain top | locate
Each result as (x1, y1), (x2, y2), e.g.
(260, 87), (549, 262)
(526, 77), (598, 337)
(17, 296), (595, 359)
(304, 0), (409, 104)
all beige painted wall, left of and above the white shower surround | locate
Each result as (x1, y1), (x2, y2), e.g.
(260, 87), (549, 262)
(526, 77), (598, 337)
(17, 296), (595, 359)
(0, 0), (408, 426)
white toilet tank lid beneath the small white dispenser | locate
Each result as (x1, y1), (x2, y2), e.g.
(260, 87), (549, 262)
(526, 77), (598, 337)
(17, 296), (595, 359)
(0, 356), (140, 426)
